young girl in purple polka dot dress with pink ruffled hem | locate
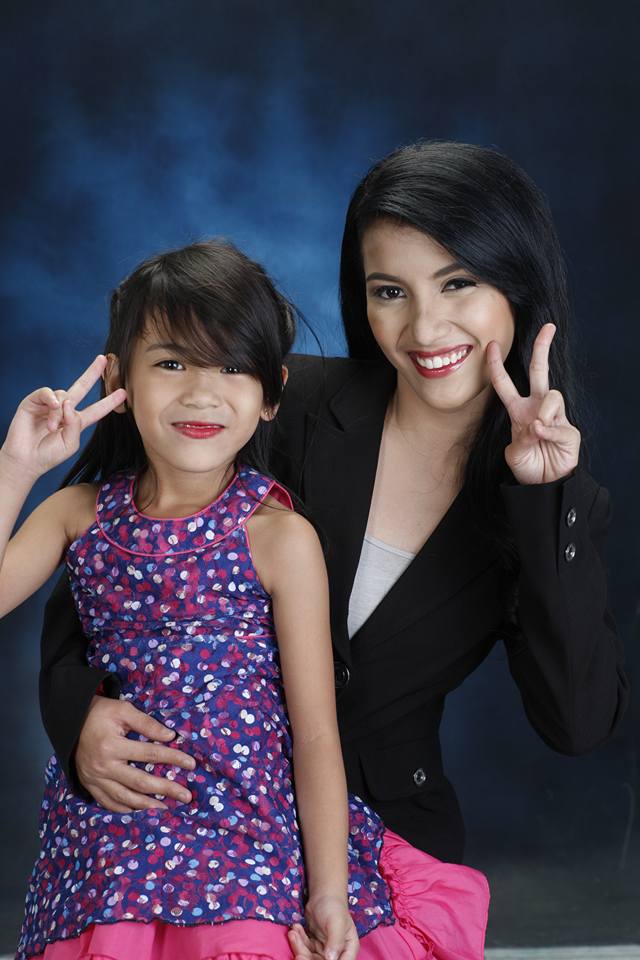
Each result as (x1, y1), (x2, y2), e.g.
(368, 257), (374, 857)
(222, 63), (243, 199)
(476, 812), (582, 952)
(0, 241), (487, 960)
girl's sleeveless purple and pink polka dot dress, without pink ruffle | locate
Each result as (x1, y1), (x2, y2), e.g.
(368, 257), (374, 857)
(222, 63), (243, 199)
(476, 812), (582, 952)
(17, 467), (393, 960)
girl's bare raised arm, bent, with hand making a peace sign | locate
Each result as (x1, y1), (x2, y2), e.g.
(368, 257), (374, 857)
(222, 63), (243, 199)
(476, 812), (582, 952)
(0, 356), (126, 616)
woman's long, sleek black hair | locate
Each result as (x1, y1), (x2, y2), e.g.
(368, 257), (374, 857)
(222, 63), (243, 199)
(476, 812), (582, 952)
(340, 141), (580, 565)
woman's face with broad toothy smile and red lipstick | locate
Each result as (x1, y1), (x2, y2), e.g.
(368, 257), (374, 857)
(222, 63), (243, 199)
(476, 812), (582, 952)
(362, 219), (514, 413)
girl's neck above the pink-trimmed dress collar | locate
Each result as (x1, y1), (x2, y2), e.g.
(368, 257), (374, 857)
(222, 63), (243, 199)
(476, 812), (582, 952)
(134, 463), (235, 519)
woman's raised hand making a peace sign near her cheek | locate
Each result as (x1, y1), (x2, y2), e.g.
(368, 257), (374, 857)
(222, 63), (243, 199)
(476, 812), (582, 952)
(487, 323), (580, 483)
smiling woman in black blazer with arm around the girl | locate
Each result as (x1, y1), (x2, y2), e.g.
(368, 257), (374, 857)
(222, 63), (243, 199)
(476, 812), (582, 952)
(37, 142), (627, 860)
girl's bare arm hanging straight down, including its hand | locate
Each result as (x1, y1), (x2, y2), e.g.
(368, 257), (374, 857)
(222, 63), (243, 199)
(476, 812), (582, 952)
(249, 508), (357, 958)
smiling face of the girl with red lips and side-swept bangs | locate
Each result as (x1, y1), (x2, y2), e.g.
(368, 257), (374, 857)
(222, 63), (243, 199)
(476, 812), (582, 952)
(108, 324), (273, 473)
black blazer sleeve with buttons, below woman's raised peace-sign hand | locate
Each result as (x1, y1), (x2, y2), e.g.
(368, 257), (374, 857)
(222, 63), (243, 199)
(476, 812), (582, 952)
(502, 466), (629, 755)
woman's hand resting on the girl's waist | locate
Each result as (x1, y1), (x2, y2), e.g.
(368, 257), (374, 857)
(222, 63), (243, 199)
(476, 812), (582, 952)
(75, 697), (195, 813)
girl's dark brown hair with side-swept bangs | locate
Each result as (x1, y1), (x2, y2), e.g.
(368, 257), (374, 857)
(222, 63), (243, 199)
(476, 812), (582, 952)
(62, 233), (296, 486)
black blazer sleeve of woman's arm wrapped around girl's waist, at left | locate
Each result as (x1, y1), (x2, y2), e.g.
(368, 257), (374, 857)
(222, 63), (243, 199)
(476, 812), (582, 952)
(39, 573), (120, 796)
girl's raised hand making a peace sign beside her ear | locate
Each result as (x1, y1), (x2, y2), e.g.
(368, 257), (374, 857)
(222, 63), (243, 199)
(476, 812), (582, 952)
(2, 354), (127, 481)
